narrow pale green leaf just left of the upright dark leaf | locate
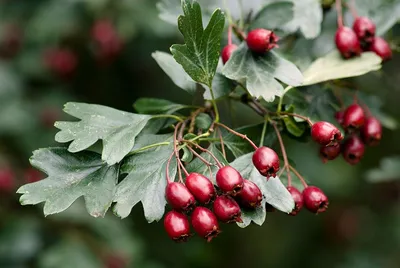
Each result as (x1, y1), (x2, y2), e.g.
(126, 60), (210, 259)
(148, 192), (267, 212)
(151, 51), (196, 94)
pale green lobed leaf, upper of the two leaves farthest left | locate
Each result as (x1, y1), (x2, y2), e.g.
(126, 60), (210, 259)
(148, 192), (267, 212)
(55, 102), (151, 165)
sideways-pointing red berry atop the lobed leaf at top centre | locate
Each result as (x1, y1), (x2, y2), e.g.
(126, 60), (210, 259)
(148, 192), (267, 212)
(246, 29), (279, 54)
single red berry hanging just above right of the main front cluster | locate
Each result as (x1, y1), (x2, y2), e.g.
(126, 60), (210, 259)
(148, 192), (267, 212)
(253, 146), (279, 178)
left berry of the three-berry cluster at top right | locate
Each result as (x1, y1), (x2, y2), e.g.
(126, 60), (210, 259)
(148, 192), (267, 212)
(335, 27), (361, 59)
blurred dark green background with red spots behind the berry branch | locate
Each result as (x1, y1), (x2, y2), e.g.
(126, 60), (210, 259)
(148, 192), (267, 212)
(0, 0), (400, 268)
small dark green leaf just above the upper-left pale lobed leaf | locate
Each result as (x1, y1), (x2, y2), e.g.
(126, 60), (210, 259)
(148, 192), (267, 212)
(133, 98), (187, 114)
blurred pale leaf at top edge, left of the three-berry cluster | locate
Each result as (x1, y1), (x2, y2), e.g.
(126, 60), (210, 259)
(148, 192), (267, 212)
(281, 0), (322, 39)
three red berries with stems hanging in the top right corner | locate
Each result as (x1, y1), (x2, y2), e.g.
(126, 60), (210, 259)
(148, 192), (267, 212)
(335, 1), (392, 61)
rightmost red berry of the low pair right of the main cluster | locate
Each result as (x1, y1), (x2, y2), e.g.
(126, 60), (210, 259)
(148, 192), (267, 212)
(302, 186), (329, 214)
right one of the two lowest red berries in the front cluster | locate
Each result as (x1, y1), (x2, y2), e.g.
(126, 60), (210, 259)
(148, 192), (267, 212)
(192, 207), (221, 242)
